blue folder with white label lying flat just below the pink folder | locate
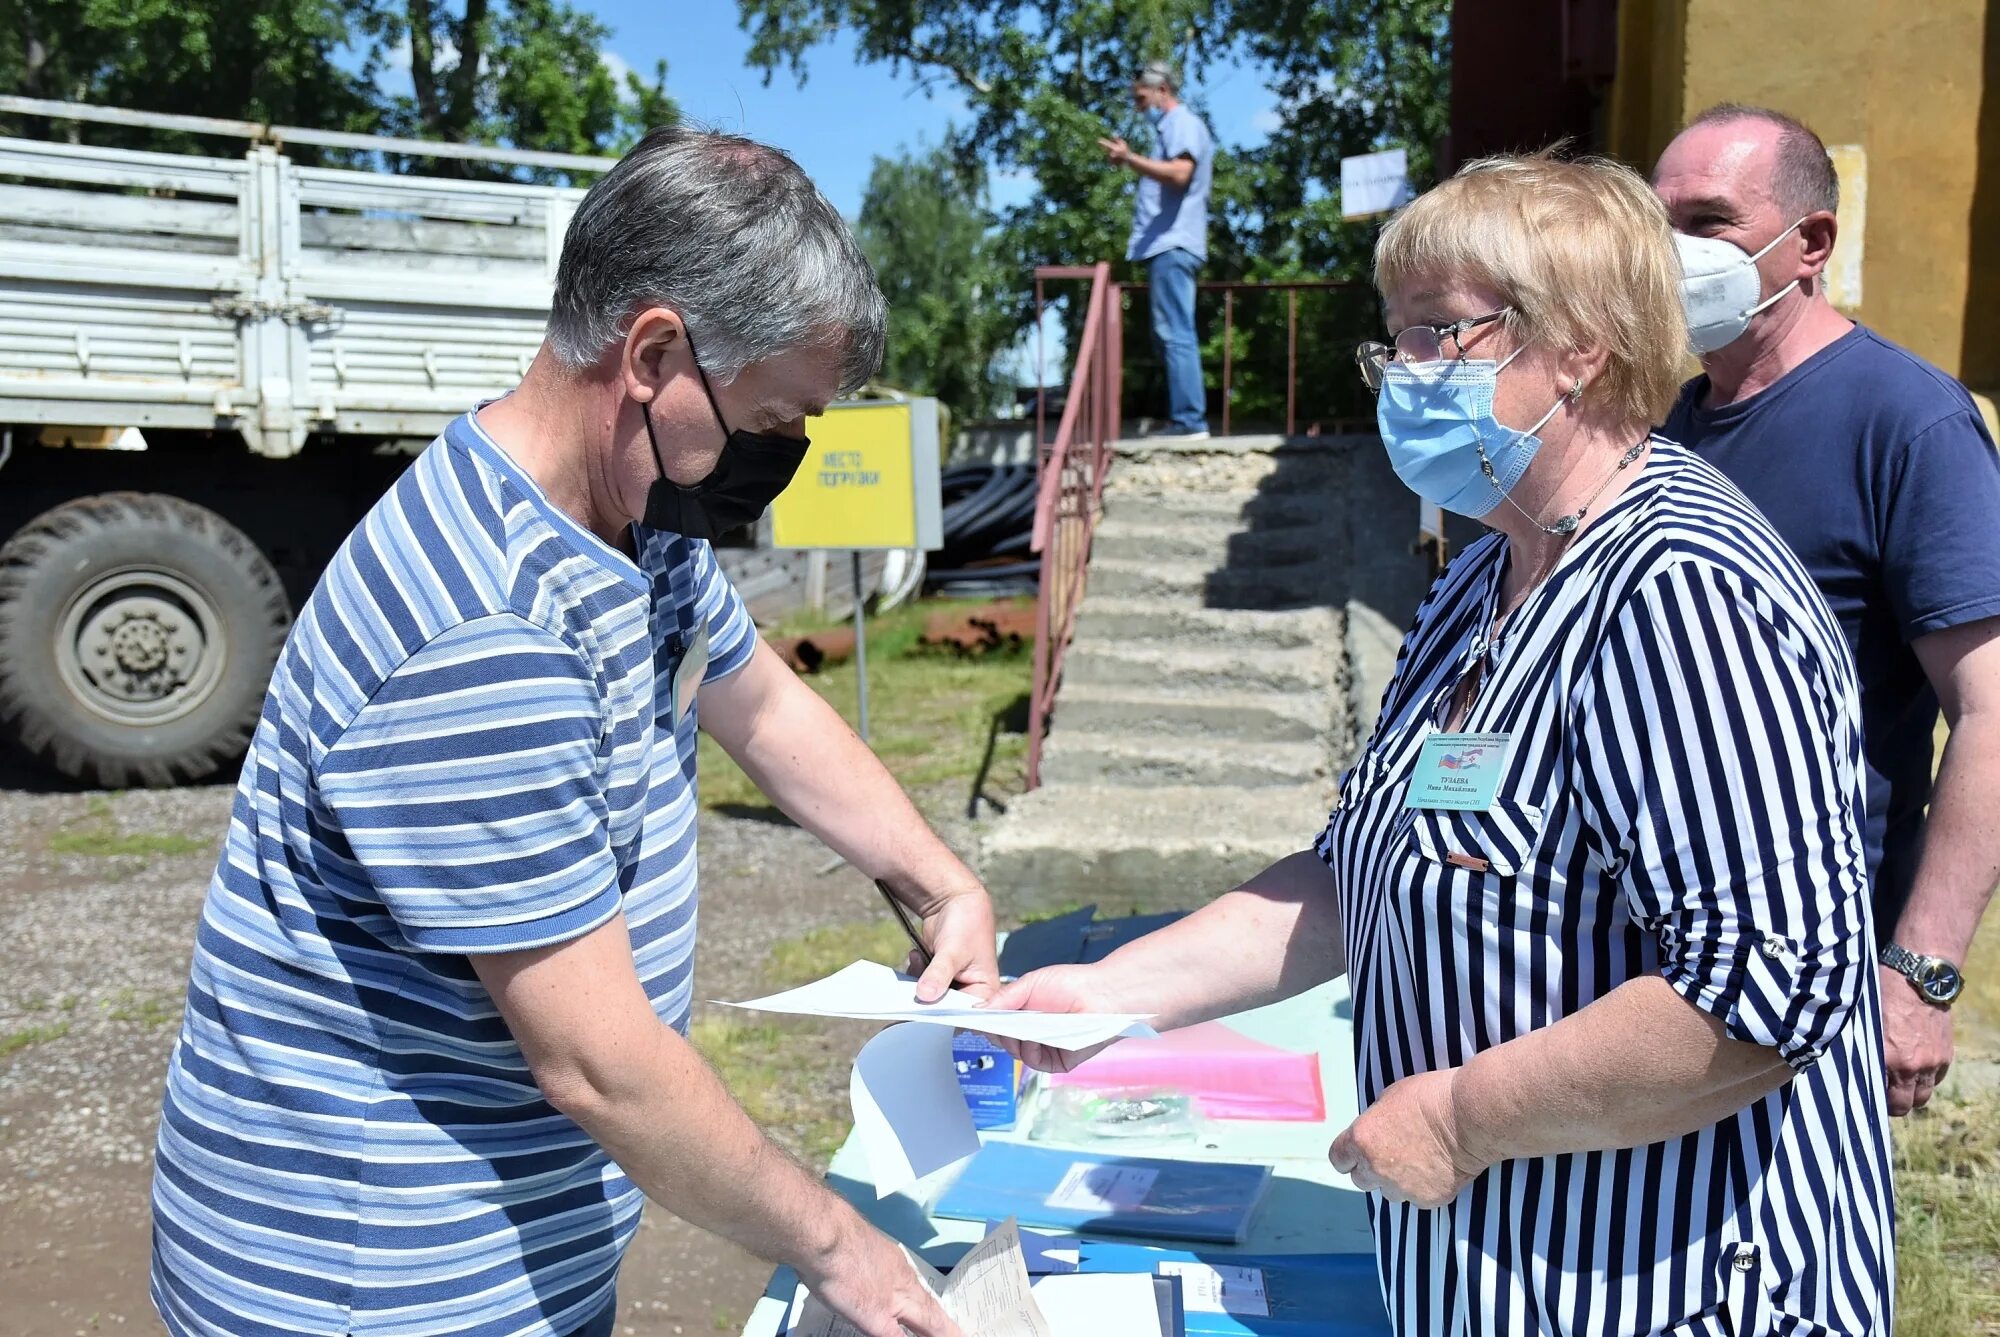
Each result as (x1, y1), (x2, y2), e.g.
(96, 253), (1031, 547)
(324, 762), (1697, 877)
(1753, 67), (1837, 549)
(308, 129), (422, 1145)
(932, 1143), (1270, 1240)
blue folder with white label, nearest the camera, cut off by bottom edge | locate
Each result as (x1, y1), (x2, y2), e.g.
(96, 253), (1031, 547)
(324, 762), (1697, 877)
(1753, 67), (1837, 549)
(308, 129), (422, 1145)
(1082, 1239), (1394, 1337)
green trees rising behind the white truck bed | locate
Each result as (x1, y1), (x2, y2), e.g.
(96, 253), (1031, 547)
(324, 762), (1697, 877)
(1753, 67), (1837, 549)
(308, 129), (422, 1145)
(0, 0), (676, 176)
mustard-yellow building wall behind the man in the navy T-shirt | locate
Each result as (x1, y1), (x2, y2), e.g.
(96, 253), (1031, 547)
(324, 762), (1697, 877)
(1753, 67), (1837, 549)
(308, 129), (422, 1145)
(1606, 0), (2000, 394)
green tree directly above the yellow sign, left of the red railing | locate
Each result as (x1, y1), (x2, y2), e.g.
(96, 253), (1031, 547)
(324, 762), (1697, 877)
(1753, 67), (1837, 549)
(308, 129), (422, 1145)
(854, 148), (1014, 418)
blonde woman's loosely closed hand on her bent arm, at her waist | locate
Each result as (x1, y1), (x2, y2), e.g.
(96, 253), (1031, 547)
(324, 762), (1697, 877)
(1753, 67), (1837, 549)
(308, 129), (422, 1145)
(1326, 1069), (1486, 1207)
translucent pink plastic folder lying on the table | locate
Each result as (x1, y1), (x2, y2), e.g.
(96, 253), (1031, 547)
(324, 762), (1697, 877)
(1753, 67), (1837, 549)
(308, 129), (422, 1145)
(1048, 1021), (1326, 1123)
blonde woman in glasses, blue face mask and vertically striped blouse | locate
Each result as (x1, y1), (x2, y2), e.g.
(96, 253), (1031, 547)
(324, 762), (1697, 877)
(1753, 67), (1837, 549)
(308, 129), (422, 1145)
(996, 156), (1894, 1337)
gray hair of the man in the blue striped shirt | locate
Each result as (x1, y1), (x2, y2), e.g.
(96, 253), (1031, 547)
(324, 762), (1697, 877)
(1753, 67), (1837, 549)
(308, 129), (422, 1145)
(548, 126), (888, 394)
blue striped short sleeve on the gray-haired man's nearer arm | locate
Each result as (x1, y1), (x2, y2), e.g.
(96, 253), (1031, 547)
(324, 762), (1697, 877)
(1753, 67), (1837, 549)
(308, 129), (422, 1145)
(318, 614), (620, 953)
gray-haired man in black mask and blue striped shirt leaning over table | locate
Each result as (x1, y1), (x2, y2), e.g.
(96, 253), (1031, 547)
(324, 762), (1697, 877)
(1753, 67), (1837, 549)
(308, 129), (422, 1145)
(152, 130), (996, 1337)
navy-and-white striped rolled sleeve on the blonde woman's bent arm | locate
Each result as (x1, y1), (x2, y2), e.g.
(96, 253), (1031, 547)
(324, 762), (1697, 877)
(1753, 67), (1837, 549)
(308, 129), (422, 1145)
(1576, 562), (1870, 1069)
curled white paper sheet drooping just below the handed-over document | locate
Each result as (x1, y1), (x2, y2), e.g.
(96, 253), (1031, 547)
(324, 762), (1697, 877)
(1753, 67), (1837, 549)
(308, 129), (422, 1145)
(848, 1025), (980, 1197)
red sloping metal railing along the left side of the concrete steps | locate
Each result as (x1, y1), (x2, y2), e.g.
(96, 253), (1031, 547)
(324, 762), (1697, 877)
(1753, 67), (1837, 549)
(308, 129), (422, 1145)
(1028, 262), (1124, 789)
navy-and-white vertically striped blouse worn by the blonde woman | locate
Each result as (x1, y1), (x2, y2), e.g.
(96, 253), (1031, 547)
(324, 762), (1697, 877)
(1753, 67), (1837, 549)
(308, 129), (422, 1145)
(1318, 442), (1894, 1337)
